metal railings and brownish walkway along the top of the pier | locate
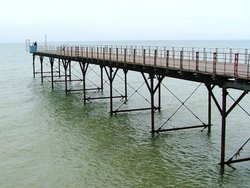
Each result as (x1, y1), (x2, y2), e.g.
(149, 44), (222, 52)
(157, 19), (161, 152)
(38, 45), (250, 79)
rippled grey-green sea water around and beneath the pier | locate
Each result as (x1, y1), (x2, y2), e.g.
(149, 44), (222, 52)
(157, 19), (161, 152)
(0, 41), (250, 188)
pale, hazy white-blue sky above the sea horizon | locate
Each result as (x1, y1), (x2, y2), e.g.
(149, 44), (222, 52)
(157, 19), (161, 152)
(0, 0), (250, 43)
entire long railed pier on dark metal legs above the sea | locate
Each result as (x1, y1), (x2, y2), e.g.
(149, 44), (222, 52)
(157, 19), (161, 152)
(33, 45), (250, 167)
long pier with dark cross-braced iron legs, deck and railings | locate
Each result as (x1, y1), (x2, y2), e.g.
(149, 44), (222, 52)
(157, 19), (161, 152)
(33, 46), (250, 168)
